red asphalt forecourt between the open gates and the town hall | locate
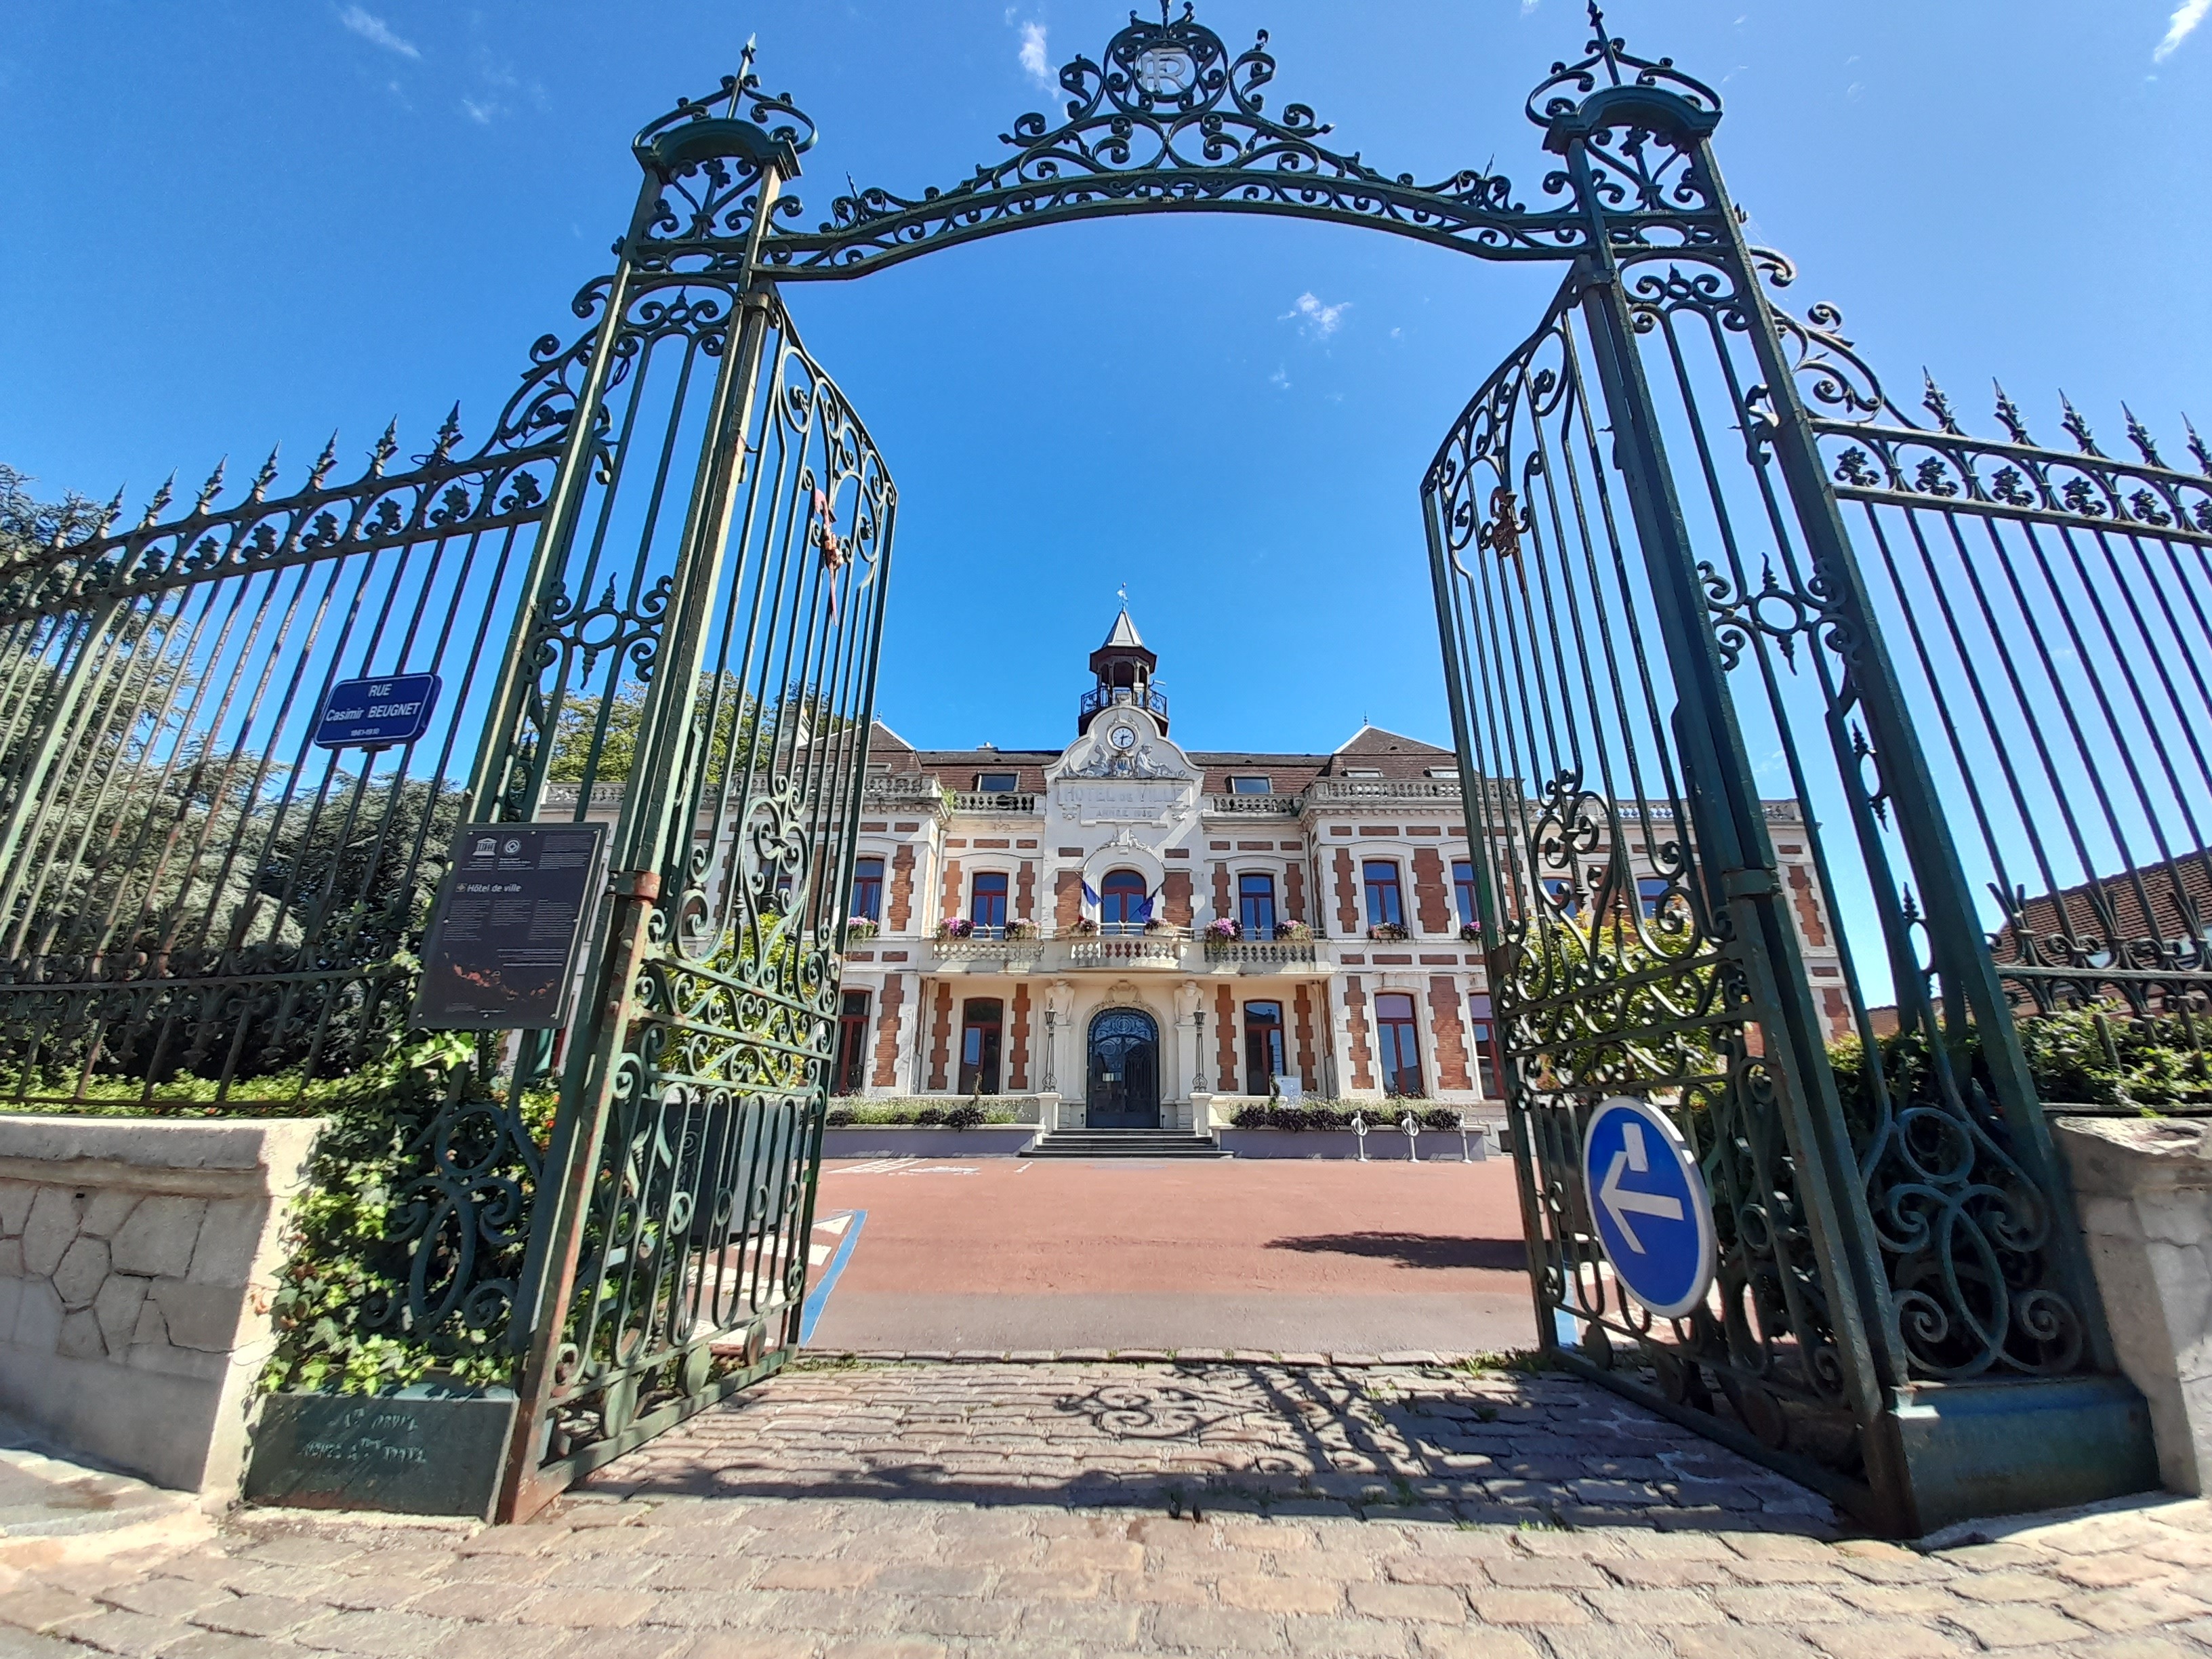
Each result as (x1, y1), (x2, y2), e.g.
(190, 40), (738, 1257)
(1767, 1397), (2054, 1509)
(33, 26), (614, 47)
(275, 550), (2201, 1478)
(812, 1157), (1535, 1354)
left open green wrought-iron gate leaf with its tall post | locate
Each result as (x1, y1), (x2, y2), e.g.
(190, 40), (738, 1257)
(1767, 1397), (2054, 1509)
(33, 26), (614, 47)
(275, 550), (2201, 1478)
(478, 77), (896, 1517)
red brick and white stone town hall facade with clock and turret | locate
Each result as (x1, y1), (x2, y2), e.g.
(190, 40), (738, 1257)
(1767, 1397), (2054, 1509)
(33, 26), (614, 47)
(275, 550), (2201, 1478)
(818, 617), (1843, 1124)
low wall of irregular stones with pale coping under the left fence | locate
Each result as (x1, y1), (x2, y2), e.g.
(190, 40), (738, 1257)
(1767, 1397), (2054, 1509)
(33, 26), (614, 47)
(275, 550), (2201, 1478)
(0, 1115), (321, 1500)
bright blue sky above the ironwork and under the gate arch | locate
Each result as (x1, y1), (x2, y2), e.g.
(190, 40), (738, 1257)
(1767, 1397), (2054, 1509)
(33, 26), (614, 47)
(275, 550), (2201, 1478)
(0, 0), (2212, 750)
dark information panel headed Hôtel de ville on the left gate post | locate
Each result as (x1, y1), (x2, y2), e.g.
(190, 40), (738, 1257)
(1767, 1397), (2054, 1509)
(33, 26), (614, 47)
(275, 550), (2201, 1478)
(413, 823), (606, 1031)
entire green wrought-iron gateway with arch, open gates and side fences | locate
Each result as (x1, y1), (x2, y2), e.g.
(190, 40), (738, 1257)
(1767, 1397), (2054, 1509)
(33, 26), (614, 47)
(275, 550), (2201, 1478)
(0, 5), (2212, 1531)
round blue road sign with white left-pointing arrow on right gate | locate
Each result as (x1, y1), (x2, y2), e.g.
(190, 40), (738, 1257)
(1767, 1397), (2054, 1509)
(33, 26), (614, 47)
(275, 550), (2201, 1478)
(1582, 1095), (1715, 1318)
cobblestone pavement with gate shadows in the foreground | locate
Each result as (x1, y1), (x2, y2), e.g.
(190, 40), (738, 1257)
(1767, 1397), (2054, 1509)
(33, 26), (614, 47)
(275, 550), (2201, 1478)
(0, 1363), (2212, 1659)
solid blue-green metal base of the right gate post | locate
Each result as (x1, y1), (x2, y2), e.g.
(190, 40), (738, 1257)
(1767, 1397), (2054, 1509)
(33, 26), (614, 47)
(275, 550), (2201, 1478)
(1867, 1376), (2159, 1537)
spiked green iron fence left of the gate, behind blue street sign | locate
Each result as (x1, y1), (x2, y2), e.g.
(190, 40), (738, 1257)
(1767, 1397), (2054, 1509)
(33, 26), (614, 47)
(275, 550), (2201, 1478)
(0, 413), (564, 1108)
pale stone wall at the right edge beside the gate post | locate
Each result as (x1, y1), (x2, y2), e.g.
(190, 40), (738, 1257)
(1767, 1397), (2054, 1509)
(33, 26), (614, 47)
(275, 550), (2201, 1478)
(2053, 1117), (2212, 1495)
